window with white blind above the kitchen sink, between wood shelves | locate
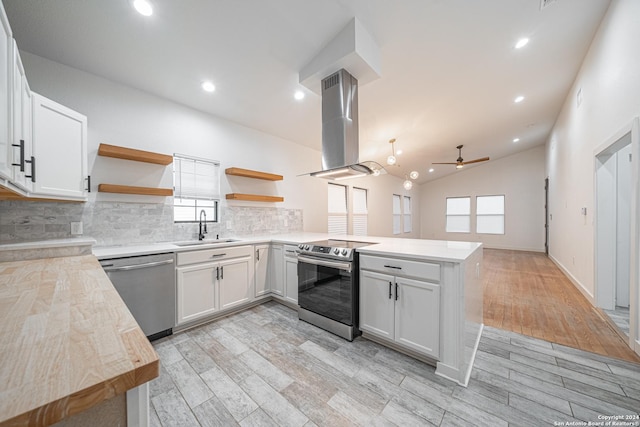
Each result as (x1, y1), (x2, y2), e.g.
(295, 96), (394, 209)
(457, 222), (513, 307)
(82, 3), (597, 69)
(173, 154), (220, 222)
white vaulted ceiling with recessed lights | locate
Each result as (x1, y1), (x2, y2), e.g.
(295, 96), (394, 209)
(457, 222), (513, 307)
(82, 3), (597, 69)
(2, 0), (610, 182)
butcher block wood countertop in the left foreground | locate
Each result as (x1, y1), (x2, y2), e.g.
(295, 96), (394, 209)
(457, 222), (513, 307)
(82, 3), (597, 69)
(0, 255), (159, 427)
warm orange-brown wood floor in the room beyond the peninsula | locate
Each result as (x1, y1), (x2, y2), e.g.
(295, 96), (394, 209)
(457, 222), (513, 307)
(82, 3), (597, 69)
(483, 249), (640, 363)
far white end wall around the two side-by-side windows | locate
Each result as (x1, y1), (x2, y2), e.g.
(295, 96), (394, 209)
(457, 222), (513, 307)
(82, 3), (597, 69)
(420, 146), (545, 251)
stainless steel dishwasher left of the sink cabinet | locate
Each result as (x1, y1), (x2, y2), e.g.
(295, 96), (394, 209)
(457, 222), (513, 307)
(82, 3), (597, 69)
(100, 253), (176, 341)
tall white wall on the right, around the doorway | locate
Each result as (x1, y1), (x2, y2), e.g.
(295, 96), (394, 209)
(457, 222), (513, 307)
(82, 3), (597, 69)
(546, 0), (640, 300)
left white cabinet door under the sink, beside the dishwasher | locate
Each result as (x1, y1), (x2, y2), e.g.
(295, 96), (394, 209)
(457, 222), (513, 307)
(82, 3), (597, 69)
(176, 263), (218, 325)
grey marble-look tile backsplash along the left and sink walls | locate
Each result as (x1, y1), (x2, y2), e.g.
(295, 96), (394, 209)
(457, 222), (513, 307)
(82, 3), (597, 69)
(0, 199), (303, 246)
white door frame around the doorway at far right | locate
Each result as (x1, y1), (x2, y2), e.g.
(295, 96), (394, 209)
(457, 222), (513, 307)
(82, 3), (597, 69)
(593, 117), (640, 355)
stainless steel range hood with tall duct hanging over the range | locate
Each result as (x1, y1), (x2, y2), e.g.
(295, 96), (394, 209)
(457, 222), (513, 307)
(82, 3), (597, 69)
(310, 69), (384, 180)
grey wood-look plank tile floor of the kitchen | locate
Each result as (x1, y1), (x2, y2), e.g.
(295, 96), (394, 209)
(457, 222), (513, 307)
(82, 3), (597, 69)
(150, 302), (640, 427)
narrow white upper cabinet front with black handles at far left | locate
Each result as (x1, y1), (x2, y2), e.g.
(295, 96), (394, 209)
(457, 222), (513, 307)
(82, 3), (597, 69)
(11, 41), (34, 191)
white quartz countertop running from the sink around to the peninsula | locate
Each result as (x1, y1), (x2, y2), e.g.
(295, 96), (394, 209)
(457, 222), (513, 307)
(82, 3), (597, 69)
(93, 233), (482, 262)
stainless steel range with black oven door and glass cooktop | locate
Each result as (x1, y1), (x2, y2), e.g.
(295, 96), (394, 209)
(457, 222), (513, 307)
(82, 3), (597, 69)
(298, 240), (372, 341)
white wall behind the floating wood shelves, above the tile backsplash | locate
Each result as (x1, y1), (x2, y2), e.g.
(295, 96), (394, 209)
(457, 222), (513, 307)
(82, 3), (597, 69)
(21, 51), (412, 237)
